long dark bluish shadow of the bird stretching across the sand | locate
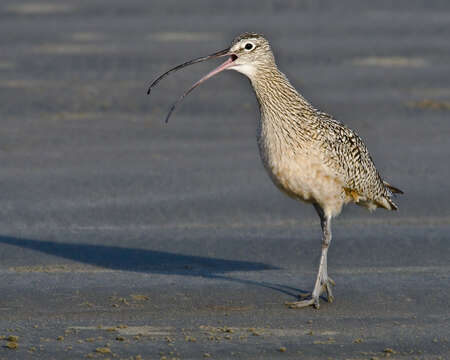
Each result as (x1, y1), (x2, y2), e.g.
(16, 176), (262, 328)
(0, 236), (305, 297)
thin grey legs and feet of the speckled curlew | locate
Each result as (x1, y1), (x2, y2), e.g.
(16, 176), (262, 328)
(287, 204), (335, 309)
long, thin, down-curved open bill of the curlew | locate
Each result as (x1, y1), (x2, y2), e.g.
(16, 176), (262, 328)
(147, 49), (237, 123)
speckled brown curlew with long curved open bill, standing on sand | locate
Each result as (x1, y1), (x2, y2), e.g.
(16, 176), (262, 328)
(147, 32), (403, 309)
